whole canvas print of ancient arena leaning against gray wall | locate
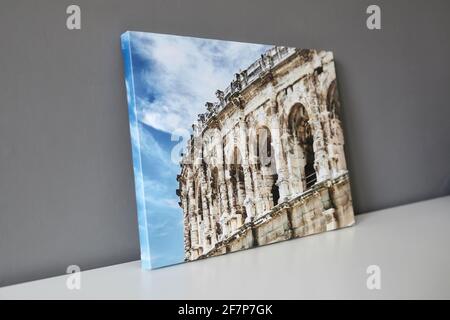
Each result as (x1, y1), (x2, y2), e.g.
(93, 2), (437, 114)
(121, 32), (354, 268)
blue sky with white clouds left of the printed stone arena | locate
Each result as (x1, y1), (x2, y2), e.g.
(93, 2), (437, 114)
(122, 32), (269, 268)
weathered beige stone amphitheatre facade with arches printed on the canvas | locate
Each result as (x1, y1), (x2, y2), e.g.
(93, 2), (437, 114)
(177, 47), (354, 260)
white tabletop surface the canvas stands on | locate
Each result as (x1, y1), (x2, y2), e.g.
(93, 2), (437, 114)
(0, 196), (450, 299)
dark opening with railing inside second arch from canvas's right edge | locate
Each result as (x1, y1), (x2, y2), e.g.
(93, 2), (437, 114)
(288, 103), (317, 190)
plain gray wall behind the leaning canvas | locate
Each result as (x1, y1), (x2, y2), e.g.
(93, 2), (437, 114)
(0, 0), (450, 286)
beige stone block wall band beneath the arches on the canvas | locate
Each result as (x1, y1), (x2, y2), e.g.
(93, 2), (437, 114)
(205, 172), (354, 257)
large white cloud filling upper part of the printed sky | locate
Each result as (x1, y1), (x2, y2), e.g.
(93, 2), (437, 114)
(133, 33), (269, 133)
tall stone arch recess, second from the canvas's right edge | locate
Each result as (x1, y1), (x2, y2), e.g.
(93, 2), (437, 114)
(287, 103), (317, 192)
